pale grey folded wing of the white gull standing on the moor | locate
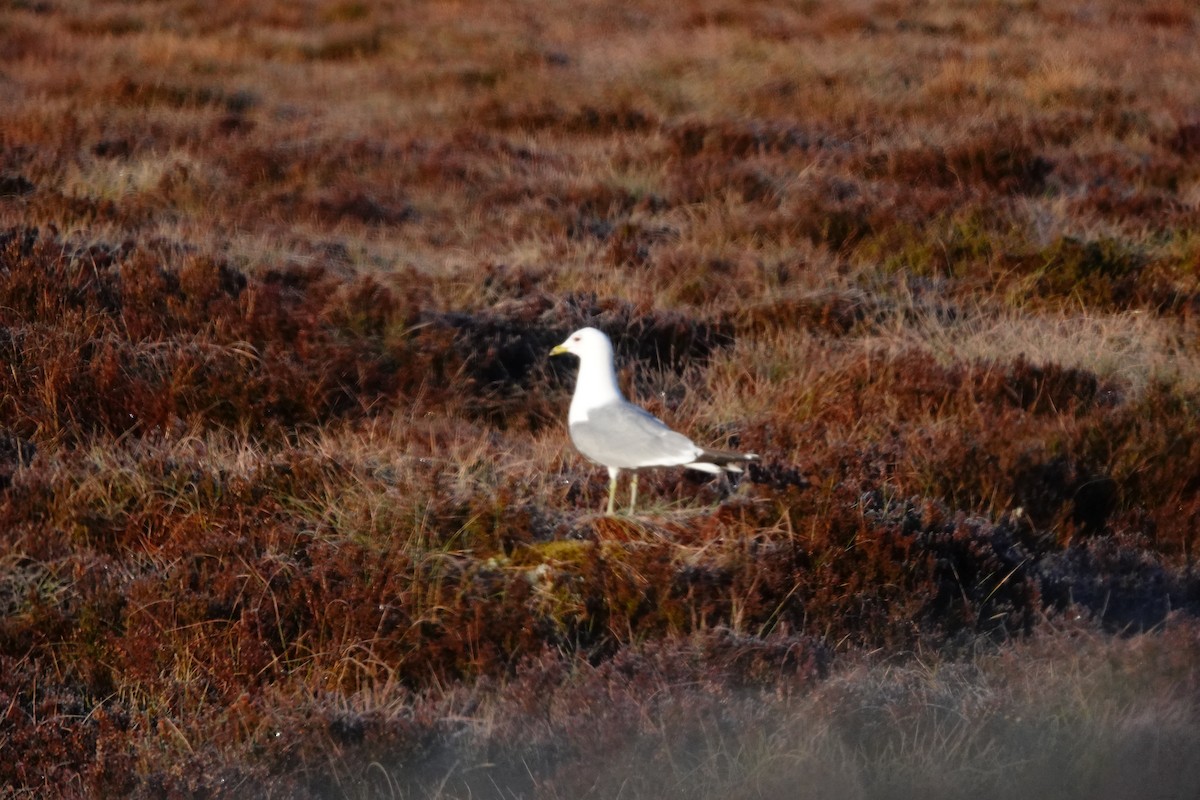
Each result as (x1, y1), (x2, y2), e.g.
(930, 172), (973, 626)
(570, 403), (701, 469)
